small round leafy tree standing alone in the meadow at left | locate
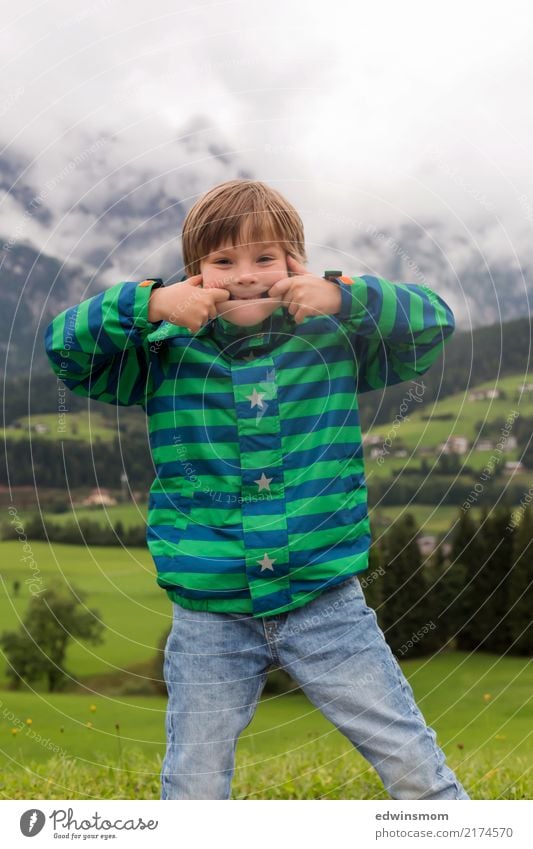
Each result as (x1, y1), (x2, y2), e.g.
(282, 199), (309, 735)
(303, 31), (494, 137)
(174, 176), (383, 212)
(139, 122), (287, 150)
(0, 585), (104, 692)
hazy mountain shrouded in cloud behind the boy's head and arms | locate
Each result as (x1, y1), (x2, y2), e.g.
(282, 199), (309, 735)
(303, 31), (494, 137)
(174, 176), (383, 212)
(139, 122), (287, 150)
(0, 121), (533, 375)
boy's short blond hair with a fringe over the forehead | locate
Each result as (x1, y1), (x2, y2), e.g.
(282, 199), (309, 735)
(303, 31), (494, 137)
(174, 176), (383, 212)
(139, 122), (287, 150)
(182, 179), (307, 277)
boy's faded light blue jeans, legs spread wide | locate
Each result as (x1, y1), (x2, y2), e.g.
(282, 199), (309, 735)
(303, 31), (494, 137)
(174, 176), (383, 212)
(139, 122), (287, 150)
(161, 577), (470, 799)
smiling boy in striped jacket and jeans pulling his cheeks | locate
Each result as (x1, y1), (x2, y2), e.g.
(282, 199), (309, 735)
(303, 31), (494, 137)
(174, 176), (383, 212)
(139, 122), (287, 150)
(46, 180), (469, 799)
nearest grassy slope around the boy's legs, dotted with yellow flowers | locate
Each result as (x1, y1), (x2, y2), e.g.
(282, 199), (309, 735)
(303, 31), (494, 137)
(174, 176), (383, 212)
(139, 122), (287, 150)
(0, 653), (533, 799)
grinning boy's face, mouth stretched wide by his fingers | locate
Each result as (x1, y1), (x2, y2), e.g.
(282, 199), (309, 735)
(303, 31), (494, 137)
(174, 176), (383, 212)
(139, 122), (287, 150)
(200, 242), (288, 327)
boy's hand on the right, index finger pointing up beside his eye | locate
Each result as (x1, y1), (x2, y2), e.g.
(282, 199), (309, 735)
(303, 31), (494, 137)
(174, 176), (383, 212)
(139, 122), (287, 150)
(268, 254), (341, 324)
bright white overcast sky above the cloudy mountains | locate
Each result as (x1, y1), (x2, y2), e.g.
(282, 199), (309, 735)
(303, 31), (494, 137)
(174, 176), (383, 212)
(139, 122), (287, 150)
(0, 0), (533, 312)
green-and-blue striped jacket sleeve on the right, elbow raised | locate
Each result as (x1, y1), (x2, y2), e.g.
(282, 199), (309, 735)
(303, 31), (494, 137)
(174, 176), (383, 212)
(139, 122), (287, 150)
(336, 275), (455, 393)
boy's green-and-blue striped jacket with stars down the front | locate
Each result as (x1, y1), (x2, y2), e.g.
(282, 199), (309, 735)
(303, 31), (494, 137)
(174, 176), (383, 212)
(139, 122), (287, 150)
(45, 272), (455, 616)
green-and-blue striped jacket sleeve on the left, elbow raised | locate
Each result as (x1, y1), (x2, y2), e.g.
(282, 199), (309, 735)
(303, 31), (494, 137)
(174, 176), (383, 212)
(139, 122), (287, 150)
(44, 279), (163, 407)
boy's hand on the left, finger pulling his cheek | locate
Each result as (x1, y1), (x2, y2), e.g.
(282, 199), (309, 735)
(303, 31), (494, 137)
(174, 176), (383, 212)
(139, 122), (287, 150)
(148, 274), (230, 333)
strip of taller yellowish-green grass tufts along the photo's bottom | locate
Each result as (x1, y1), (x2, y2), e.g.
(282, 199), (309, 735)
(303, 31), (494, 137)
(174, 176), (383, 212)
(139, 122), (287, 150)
(0, 743), (531, 800)
